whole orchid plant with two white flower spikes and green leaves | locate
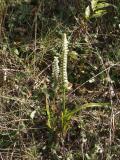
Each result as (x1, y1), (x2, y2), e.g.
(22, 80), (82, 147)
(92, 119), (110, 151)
(44, 34), (107, 137)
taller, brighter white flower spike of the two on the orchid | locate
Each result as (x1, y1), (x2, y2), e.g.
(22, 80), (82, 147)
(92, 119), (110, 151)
(61, 33), (68, 89)
